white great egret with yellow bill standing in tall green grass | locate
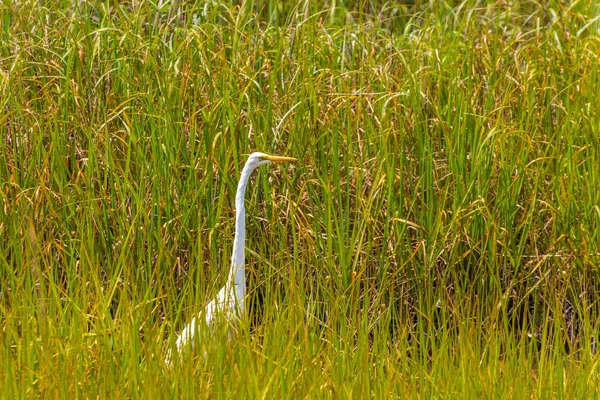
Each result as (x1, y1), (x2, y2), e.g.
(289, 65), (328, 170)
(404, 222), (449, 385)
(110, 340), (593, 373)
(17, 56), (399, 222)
(165, 152), (296, 365)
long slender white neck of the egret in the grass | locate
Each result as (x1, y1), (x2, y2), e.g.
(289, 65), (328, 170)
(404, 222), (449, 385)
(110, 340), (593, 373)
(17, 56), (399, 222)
(228, 160), (256, 293)
